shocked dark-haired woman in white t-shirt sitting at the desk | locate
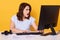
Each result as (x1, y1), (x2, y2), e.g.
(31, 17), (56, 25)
(10, 3), (37, 33)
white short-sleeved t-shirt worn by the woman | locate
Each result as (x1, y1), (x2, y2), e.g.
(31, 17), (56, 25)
(11, 15), (35, 30)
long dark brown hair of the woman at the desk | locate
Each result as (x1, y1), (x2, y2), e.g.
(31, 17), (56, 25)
(16, 3), (31, 21)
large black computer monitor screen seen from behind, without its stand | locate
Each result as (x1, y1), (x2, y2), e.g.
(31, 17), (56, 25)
(38, 5), (60, 34)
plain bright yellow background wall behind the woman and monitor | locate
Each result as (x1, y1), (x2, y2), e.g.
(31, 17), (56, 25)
(0, 0), (60, 31)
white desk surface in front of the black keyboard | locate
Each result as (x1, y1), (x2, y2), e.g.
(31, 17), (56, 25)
(0, 33), (60, 40)
